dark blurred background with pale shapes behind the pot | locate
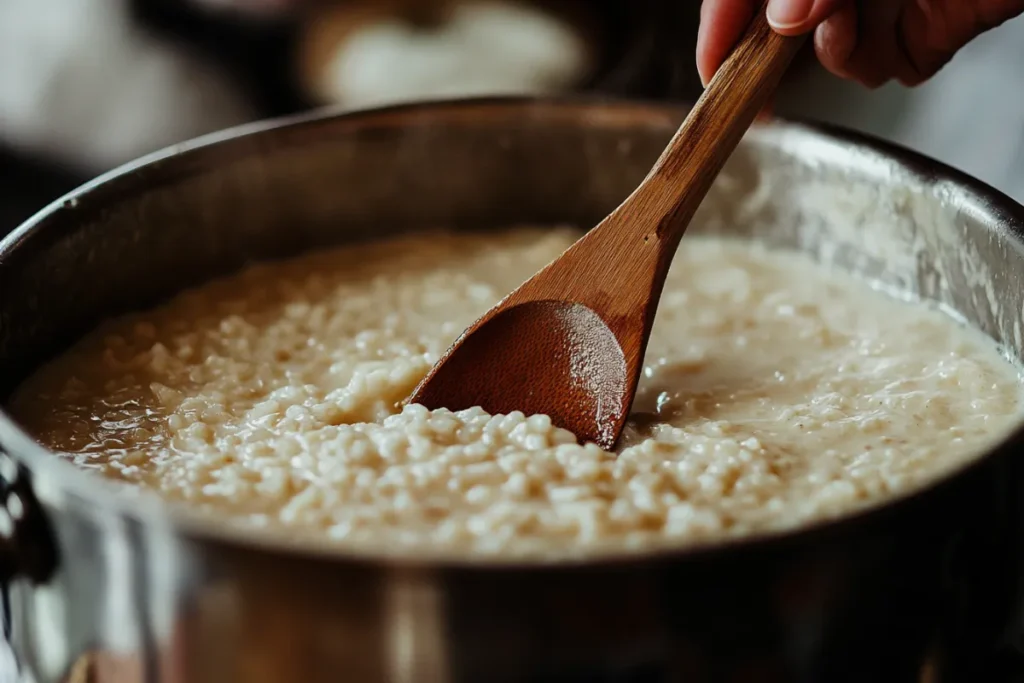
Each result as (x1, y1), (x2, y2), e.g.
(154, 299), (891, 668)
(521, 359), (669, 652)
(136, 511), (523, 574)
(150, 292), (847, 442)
(0, 0), (1024, 233)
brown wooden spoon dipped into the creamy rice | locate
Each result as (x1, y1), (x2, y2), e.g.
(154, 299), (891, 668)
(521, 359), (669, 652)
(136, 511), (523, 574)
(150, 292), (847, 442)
(409, 6), (803, 449)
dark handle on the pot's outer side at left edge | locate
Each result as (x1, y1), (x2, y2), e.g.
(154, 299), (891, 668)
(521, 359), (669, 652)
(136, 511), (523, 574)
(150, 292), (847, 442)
(0, 449), (57, 590)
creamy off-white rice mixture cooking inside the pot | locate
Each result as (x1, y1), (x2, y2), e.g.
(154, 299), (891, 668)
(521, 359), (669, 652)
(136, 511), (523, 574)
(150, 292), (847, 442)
(11, 228), (1021, 554)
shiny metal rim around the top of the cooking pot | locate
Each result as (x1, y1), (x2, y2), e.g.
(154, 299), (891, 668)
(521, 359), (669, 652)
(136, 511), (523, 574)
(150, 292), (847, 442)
(0, 95), (1024, 570)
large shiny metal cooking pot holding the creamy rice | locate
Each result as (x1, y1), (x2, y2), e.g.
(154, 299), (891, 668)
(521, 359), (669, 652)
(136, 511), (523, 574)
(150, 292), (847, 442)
(0, 100), (1024, 683)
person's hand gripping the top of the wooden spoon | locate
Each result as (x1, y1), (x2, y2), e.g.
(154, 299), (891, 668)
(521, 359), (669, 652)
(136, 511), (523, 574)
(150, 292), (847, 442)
(697, 0), (1024, 88)
